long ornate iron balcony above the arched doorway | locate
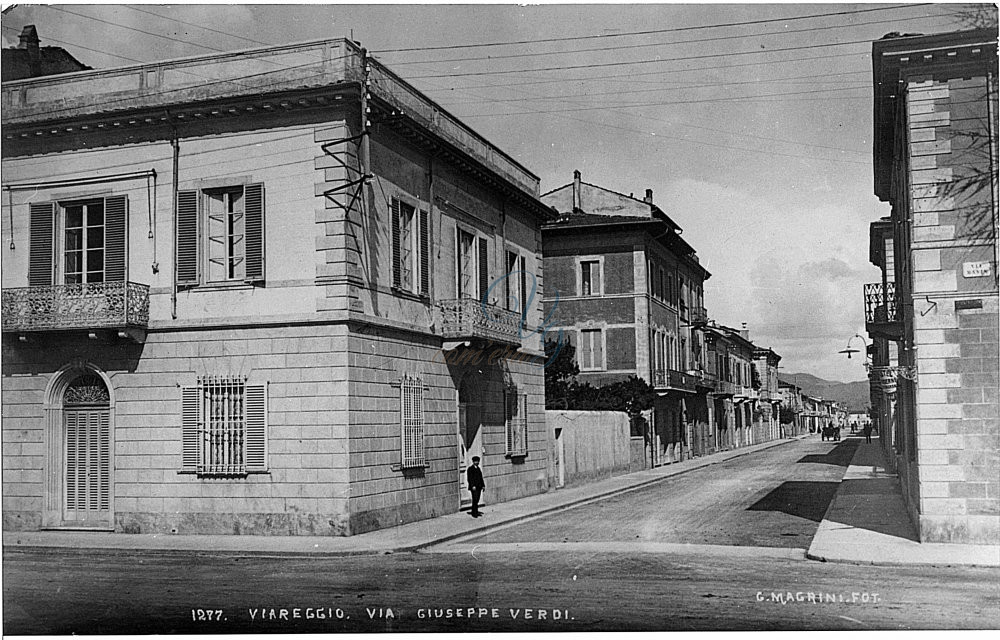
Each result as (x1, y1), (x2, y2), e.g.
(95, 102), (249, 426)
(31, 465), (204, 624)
(2, 282), (149, 342)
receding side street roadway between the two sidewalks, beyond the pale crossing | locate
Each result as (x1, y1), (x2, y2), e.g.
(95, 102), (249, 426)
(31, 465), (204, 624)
(467, 439), (858, 549)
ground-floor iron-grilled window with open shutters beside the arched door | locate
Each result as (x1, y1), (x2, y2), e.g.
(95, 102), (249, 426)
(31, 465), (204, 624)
(181, 376), (267, 476)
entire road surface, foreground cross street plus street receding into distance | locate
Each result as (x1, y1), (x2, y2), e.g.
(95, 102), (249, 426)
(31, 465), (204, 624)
(3, 441), (1000, 634)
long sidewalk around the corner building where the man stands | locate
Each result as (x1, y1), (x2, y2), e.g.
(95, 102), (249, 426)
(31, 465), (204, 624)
(3, 436), (809, 556)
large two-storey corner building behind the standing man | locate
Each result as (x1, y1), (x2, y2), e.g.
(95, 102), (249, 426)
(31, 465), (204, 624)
(2, 35), (556, 535)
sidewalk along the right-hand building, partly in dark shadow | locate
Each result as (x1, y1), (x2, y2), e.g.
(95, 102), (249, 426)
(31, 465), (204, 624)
(806, 438), (1000, 567)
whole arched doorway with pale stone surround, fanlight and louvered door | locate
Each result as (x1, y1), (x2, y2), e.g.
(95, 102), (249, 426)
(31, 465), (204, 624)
(43, 366), (114, 530)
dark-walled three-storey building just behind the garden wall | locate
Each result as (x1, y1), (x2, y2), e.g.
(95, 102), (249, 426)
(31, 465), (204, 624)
(542, 171), (714, 465)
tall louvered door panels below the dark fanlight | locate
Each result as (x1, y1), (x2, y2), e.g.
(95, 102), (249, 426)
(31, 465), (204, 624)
(63, 407), (111, 528)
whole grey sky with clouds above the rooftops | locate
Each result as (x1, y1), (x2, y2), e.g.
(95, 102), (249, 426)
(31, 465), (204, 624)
(2, 3), (984, 381)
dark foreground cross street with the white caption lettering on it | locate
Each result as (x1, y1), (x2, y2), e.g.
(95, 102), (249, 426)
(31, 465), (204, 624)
(3, 550), (1000, 634)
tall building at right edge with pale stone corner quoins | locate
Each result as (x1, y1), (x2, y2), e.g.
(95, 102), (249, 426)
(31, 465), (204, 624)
(864, 29), (1000, 544)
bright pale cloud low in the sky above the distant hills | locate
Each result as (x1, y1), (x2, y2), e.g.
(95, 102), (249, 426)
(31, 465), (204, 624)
(658, 179), (876, 380)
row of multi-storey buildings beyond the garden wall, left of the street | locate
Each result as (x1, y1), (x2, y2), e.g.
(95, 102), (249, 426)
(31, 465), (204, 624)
(541, 171), (804, 466)
